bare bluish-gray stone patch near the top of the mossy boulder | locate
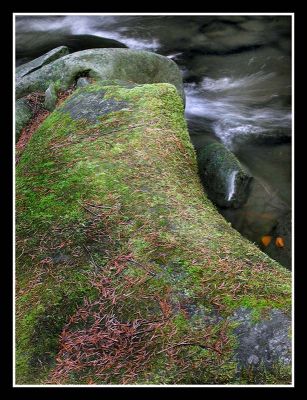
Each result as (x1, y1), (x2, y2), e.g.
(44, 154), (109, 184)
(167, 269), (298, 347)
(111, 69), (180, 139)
(60, 90), (128, 123)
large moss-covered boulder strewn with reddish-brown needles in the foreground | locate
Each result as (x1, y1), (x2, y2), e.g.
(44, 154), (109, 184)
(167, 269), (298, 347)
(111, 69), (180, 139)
(16, 82), (291, 385)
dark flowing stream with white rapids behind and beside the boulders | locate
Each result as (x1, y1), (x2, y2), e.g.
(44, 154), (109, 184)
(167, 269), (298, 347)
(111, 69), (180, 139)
(16, 15), (291, 267)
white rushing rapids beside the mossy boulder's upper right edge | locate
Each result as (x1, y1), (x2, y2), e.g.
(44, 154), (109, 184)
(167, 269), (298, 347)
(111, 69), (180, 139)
(185, 72), (292, 148)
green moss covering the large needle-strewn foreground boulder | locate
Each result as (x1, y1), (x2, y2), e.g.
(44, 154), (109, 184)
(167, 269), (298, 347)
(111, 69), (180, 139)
(16, 84), (291, 383)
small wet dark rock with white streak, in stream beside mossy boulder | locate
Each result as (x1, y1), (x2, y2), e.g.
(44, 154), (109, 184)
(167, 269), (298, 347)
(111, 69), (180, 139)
(197, 142), (253, 208)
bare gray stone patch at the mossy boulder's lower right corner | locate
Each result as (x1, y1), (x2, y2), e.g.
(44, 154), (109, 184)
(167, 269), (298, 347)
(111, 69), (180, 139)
(232, 308), (291, 368)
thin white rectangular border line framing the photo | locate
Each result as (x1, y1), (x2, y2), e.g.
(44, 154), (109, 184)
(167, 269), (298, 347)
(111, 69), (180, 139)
(12, 12), (295, 388)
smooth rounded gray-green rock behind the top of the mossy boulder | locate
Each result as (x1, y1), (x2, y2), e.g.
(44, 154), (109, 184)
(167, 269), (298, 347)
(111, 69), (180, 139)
(16, 49), (184, 98)
